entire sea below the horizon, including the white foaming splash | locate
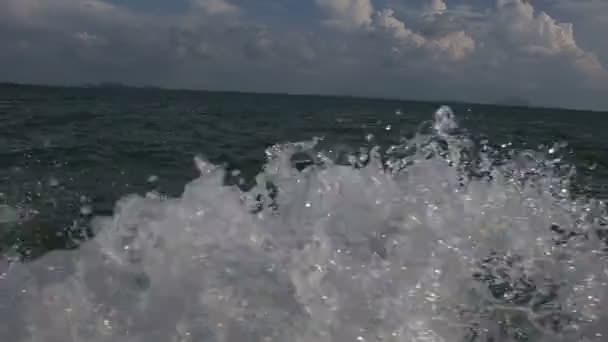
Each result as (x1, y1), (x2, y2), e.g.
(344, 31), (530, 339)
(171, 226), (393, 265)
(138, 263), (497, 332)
(0, 85), (608, 342)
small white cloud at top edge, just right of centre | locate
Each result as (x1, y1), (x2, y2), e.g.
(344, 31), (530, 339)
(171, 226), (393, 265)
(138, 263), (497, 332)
(316, 0), (374, 30)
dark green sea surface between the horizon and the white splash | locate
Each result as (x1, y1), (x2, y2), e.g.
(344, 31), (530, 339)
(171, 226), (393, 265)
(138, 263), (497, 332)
(0, 87), (608, 256)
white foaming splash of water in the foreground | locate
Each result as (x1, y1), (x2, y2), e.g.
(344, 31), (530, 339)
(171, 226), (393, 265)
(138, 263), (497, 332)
(0, 107), (608, 342)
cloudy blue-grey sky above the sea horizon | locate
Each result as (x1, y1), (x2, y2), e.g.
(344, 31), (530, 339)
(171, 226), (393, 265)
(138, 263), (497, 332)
(0, 0), (608, 110)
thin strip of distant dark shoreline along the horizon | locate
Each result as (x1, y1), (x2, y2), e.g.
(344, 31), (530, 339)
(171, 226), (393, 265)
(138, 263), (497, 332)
(0, 82), (608, 113)
